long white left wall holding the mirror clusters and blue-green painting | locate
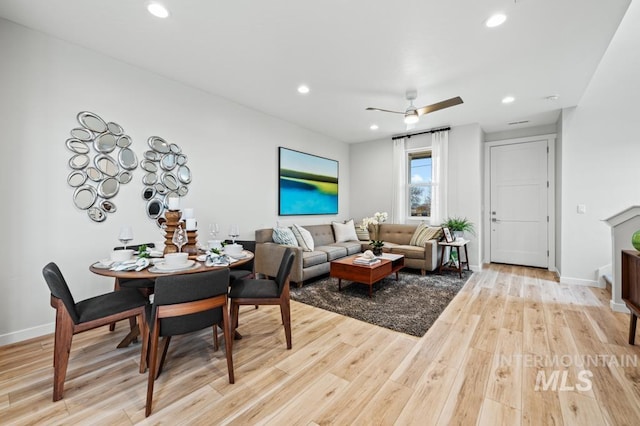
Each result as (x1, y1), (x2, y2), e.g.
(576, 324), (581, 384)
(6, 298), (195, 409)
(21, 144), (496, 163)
(0, 19), (350, 344)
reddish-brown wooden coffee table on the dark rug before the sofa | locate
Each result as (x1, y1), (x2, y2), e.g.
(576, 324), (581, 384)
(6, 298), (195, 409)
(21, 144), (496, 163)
(329, 253), (404, 297)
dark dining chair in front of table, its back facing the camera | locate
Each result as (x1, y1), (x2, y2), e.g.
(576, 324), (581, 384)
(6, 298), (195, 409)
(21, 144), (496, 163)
(143, 269), (234, 416)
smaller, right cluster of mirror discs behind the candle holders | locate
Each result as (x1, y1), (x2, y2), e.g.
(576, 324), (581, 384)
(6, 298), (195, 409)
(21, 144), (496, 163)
(140, 136), (191, 226)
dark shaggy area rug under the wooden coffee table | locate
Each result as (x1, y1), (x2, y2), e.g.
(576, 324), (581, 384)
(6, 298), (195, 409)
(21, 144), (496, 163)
(291, 271), (471, 337)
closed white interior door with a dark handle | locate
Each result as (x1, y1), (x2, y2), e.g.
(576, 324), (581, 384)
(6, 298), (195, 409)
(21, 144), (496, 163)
(490, 140), (549, 268)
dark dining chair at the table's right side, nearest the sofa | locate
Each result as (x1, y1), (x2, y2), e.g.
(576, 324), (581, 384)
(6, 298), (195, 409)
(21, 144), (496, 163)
(229, 248), (296, 349)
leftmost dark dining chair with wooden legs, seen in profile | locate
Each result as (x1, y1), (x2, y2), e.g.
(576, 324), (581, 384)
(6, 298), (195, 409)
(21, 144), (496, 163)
(42, 262), (149, 401)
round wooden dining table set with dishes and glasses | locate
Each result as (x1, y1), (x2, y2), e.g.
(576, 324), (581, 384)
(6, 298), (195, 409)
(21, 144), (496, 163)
(89, 250), (254, 348)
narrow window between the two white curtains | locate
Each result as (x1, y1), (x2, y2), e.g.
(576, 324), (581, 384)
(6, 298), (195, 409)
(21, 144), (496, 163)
(407, 151), (433, 218)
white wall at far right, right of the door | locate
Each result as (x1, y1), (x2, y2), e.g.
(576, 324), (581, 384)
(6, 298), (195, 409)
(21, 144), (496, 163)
(561, 2), (640, 285)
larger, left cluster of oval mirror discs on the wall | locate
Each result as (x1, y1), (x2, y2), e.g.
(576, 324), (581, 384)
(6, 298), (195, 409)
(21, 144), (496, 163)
(66, 111), (138, 222)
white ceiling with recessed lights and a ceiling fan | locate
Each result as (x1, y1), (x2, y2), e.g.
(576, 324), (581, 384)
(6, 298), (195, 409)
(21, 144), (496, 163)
(0, 0), (630, 142)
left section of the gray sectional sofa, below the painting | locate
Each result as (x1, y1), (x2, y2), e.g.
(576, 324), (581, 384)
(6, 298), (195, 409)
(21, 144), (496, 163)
(254, 224), (361, 287)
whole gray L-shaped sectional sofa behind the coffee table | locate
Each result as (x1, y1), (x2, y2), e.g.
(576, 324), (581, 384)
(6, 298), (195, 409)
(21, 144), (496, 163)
(254, 223), (439, 287)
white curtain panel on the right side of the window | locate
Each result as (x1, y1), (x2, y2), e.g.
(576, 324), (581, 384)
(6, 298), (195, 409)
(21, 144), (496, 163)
(431, 130), (449, 226)
